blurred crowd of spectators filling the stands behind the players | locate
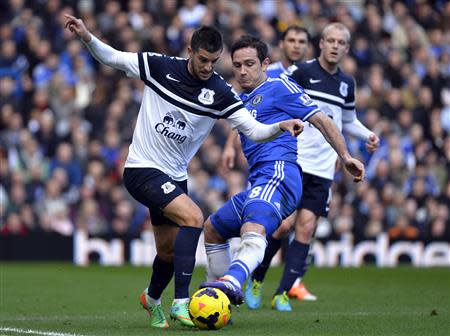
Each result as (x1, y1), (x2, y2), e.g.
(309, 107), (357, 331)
(0, 0), (450, 241)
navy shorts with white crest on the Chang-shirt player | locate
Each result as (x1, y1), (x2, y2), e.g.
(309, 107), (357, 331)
(123, 168), (188, 226)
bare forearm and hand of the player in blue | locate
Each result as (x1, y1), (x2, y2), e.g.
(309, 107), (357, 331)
(308, 112), (365, 182)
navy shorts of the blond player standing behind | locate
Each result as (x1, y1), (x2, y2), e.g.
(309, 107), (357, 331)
(298, 173), (333, 217)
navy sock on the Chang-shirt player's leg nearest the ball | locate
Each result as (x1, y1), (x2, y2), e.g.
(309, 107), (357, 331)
(174, 226), (202, 299)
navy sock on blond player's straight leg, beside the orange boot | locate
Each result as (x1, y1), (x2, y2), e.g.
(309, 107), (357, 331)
(275, 239), (309, 295)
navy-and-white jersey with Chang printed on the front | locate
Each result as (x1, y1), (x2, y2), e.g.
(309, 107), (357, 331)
(110, 53), (248, 181)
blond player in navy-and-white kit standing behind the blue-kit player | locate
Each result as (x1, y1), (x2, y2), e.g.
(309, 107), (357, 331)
(246, 23), (379, 311)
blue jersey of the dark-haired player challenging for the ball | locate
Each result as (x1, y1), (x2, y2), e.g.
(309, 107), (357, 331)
(240, 76), (320, 169)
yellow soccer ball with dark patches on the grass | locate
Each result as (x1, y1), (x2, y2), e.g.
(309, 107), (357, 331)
(189, 288), (231, 329)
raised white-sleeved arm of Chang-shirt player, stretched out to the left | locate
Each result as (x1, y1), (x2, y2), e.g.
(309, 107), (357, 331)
(64, 14), (139, 77)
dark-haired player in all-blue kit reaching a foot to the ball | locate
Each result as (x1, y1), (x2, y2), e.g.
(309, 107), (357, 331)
(200, 35), (364, 304)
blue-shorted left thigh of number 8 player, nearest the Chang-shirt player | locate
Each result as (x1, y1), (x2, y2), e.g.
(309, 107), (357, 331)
(209, 192), (246, 240)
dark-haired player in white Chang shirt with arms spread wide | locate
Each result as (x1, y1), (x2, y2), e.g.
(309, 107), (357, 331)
(65, 15), (302, 328)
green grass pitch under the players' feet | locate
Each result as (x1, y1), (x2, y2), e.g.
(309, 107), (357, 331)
(0, 262), (450, 336)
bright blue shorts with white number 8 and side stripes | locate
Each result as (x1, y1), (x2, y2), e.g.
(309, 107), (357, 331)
(210, 161), (302, 239)
